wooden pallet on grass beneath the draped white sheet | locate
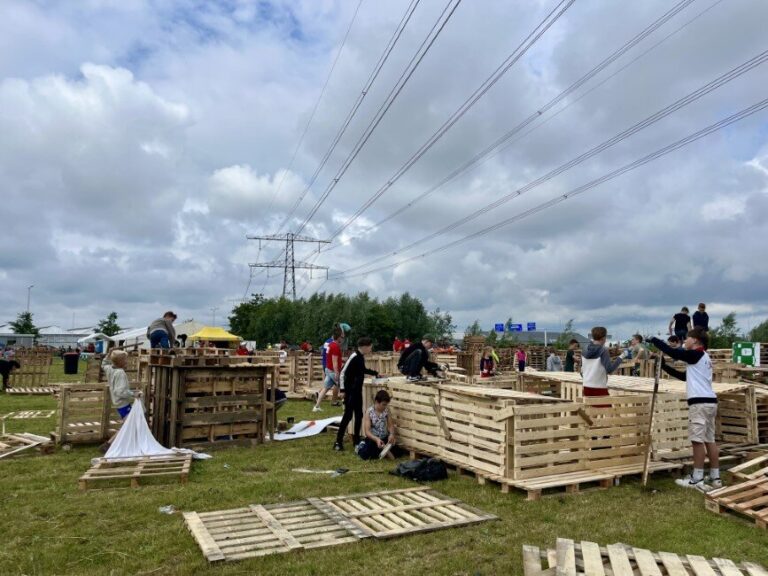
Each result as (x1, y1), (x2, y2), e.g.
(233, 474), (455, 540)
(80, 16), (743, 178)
(78, 454), (192, 490)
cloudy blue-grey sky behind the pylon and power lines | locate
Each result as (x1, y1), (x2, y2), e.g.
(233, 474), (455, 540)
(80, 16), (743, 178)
(0, 0), (768, 342)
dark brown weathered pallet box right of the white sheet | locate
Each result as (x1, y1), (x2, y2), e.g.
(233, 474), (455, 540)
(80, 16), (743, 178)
(151, 356), (277, 448)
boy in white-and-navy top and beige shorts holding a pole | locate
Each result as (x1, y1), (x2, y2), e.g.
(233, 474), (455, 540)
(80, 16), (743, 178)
(651, 327), (723, 492)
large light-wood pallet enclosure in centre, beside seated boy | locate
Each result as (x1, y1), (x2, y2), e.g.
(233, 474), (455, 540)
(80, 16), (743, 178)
(367, 378), (684, 499)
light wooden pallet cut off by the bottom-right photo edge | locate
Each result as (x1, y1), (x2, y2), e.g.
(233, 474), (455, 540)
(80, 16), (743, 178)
(523, 538), (768, 576)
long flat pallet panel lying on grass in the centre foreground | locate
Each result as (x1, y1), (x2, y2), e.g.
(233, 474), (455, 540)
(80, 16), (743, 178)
(184, 487), (496, 562)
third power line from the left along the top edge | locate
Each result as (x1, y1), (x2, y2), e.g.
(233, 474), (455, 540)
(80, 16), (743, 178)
(296, 0), (464, 234)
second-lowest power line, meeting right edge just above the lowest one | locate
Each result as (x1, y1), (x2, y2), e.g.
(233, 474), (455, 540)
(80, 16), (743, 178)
(338, 50), (768, 270)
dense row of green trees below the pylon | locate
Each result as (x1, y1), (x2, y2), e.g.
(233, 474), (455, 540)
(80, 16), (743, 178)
(229, 292), (456, 350)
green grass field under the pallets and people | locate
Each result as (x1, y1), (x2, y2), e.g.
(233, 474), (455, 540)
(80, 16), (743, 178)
(0, 395), (768, 576)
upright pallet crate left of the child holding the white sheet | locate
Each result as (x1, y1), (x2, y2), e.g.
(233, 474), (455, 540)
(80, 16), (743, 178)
(51, 384), (122, 444)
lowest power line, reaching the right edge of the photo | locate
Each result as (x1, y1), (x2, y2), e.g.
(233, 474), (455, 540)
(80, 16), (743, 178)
(332, 98), (768, 279)
